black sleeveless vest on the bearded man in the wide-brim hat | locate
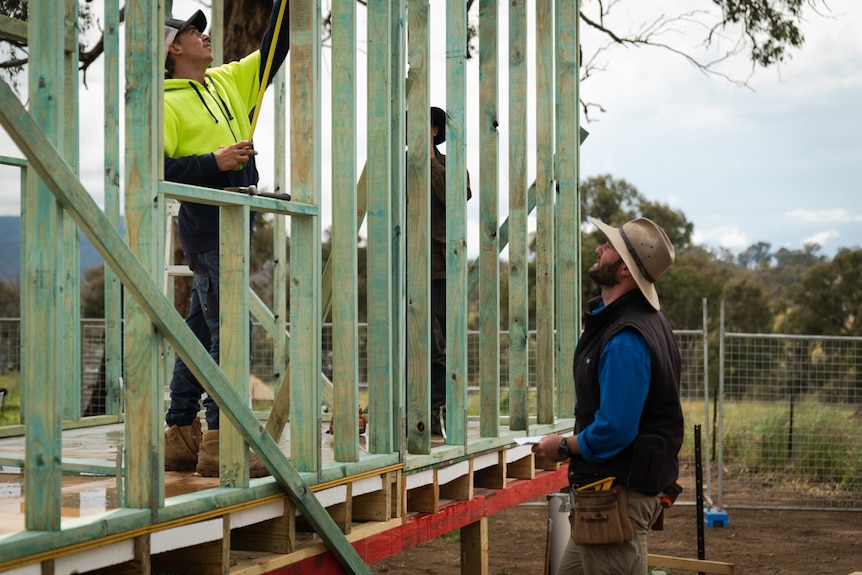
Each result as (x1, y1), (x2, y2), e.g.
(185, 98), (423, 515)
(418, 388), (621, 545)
(569, 290), (684, 495)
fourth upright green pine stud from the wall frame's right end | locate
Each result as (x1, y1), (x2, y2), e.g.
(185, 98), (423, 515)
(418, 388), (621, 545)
(476, 0), (502, 437)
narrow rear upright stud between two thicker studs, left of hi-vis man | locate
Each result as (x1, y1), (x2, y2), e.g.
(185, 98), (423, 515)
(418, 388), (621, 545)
(103, 0), (123, 415)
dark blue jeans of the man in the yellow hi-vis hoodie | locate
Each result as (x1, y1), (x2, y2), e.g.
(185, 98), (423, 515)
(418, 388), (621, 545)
(165, 251), (219, 429)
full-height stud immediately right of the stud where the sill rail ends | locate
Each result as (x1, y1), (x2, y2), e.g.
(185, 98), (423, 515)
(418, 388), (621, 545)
(332, 0), (359, 461)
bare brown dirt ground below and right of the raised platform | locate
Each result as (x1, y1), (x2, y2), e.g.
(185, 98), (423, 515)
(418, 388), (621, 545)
(371, 501), (862, 575)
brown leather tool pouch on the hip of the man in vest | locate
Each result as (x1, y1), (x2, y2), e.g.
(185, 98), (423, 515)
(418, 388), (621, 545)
(569, 485), (634, 545)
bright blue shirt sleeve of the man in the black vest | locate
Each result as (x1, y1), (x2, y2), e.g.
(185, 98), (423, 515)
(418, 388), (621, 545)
(578, 306), (652, 461)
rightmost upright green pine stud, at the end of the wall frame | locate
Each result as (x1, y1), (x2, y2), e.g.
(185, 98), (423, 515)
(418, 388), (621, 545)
(554, 0), (587, 417)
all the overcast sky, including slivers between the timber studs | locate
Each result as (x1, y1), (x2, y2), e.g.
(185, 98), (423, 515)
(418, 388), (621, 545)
(0, 0), (862, 255)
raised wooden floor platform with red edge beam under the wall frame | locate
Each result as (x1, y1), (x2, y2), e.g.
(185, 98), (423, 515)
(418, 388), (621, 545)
(0, 424), (567, 575)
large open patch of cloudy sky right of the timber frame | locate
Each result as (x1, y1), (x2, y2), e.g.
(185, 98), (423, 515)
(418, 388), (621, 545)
(581, 0), (862, 255)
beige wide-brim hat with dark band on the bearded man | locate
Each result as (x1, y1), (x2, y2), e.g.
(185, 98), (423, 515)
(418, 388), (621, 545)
(590, 218), (676, 309)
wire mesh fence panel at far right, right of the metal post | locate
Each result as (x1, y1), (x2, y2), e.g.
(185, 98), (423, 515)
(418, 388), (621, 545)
(719, 333), (862, 509)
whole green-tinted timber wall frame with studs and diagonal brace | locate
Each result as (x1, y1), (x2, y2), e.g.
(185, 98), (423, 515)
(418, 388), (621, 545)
(0, 0), (583, 573)
